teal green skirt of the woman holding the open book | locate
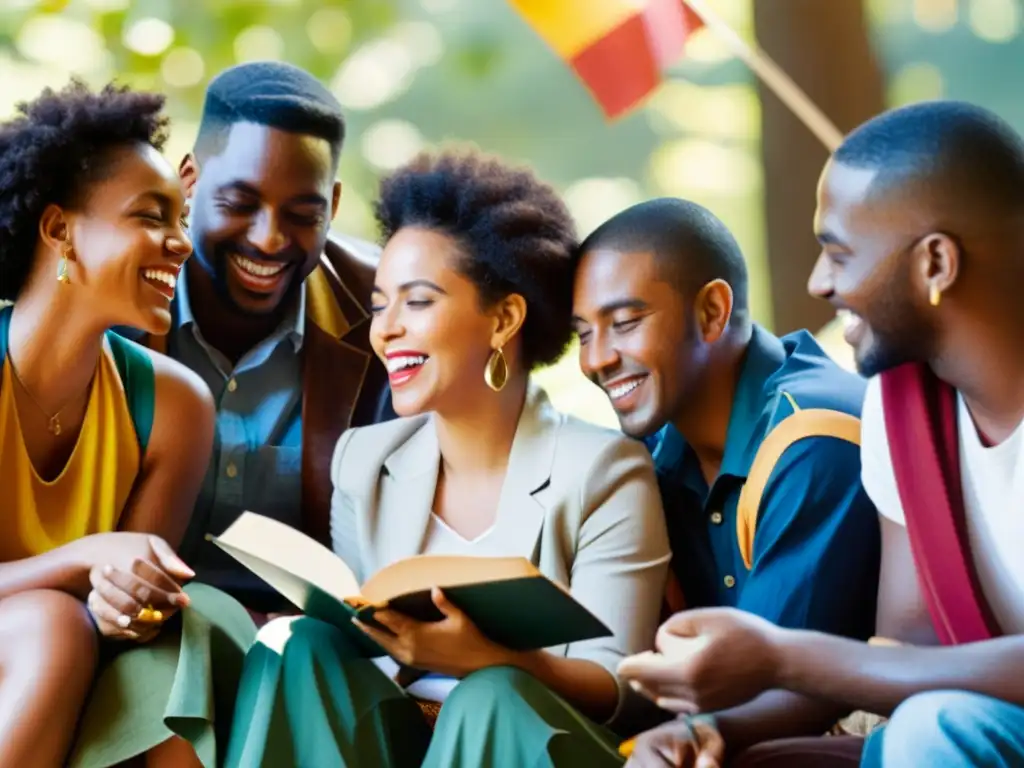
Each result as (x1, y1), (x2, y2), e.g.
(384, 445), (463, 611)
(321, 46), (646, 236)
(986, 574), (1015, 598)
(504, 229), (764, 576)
(226, 617), (624, 768)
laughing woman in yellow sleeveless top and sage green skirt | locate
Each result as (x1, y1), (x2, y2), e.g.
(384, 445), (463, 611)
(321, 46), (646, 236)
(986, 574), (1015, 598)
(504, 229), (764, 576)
(0, 84), (255, 768)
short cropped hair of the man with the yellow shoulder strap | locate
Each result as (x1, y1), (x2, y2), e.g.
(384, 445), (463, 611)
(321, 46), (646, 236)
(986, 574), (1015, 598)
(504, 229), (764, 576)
(578, 198), (749, 323)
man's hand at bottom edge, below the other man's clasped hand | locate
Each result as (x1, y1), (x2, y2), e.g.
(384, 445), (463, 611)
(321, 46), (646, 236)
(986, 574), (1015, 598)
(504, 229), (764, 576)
(626, 716), (725, 768)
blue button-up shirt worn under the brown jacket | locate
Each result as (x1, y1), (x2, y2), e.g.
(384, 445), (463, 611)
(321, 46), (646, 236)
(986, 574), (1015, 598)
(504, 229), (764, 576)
(167, 279), (306, 603)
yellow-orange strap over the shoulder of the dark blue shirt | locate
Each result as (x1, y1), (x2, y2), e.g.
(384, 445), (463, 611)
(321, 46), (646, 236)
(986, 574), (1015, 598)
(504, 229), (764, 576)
(736, 392), (860, 570)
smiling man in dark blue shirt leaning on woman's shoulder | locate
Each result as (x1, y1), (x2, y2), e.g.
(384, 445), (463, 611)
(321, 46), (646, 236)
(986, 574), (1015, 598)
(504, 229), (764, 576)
(573, 199), (880, 765)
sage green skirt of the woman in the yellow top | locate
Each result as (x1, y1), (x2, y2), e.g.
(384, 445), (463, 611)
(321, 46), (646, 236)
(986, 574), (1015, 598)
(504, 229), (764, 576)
(68, 584), (256, 768)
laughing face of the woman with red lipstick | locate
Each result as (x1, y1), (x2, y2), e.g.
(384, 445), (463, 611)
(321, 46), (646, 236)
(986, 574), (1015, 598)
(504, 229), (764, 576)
(370, 226), (508, 416)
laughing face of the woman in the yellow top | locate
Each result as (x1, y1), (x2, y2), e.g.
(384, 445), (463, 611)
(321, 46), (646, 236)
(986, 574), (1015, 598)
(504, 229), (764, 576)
(62, 144), (191, 334)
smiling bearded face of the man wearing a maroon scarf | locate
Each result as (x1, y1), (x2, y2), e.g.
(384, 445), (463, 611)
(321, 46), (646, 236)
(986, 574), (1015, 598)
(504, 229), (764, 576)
(808, 162), (938, 376)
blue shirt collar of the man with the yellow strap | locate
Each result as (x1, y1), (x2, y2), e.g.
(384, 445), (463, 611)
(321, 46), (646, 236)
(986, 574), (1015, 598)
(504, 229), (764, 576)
(645, 325), (786, 477)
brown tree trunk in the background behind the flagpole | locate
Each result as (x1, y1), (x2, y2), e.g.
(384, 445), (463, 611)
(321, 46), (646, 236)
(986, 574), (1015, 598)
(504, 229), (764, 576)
(751, 0), (885, 334)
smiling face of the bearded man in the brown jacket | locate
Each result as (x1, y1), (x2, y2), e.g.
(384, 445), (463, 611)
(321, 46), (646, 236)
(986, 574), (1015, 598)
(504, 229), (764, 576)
(182, 123), (341, 314)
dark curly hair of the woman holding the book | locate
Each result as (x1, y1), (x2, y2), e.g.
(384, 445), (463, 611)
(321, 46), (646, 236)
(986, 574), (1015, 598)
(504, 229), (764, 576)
(375, 151), (578, 370)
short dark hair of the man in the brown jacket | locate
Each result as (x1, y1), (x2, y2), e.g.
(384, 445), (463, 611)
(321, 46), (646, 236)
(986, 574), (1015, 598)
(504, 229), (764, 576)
(196, 61), (345, 166)
